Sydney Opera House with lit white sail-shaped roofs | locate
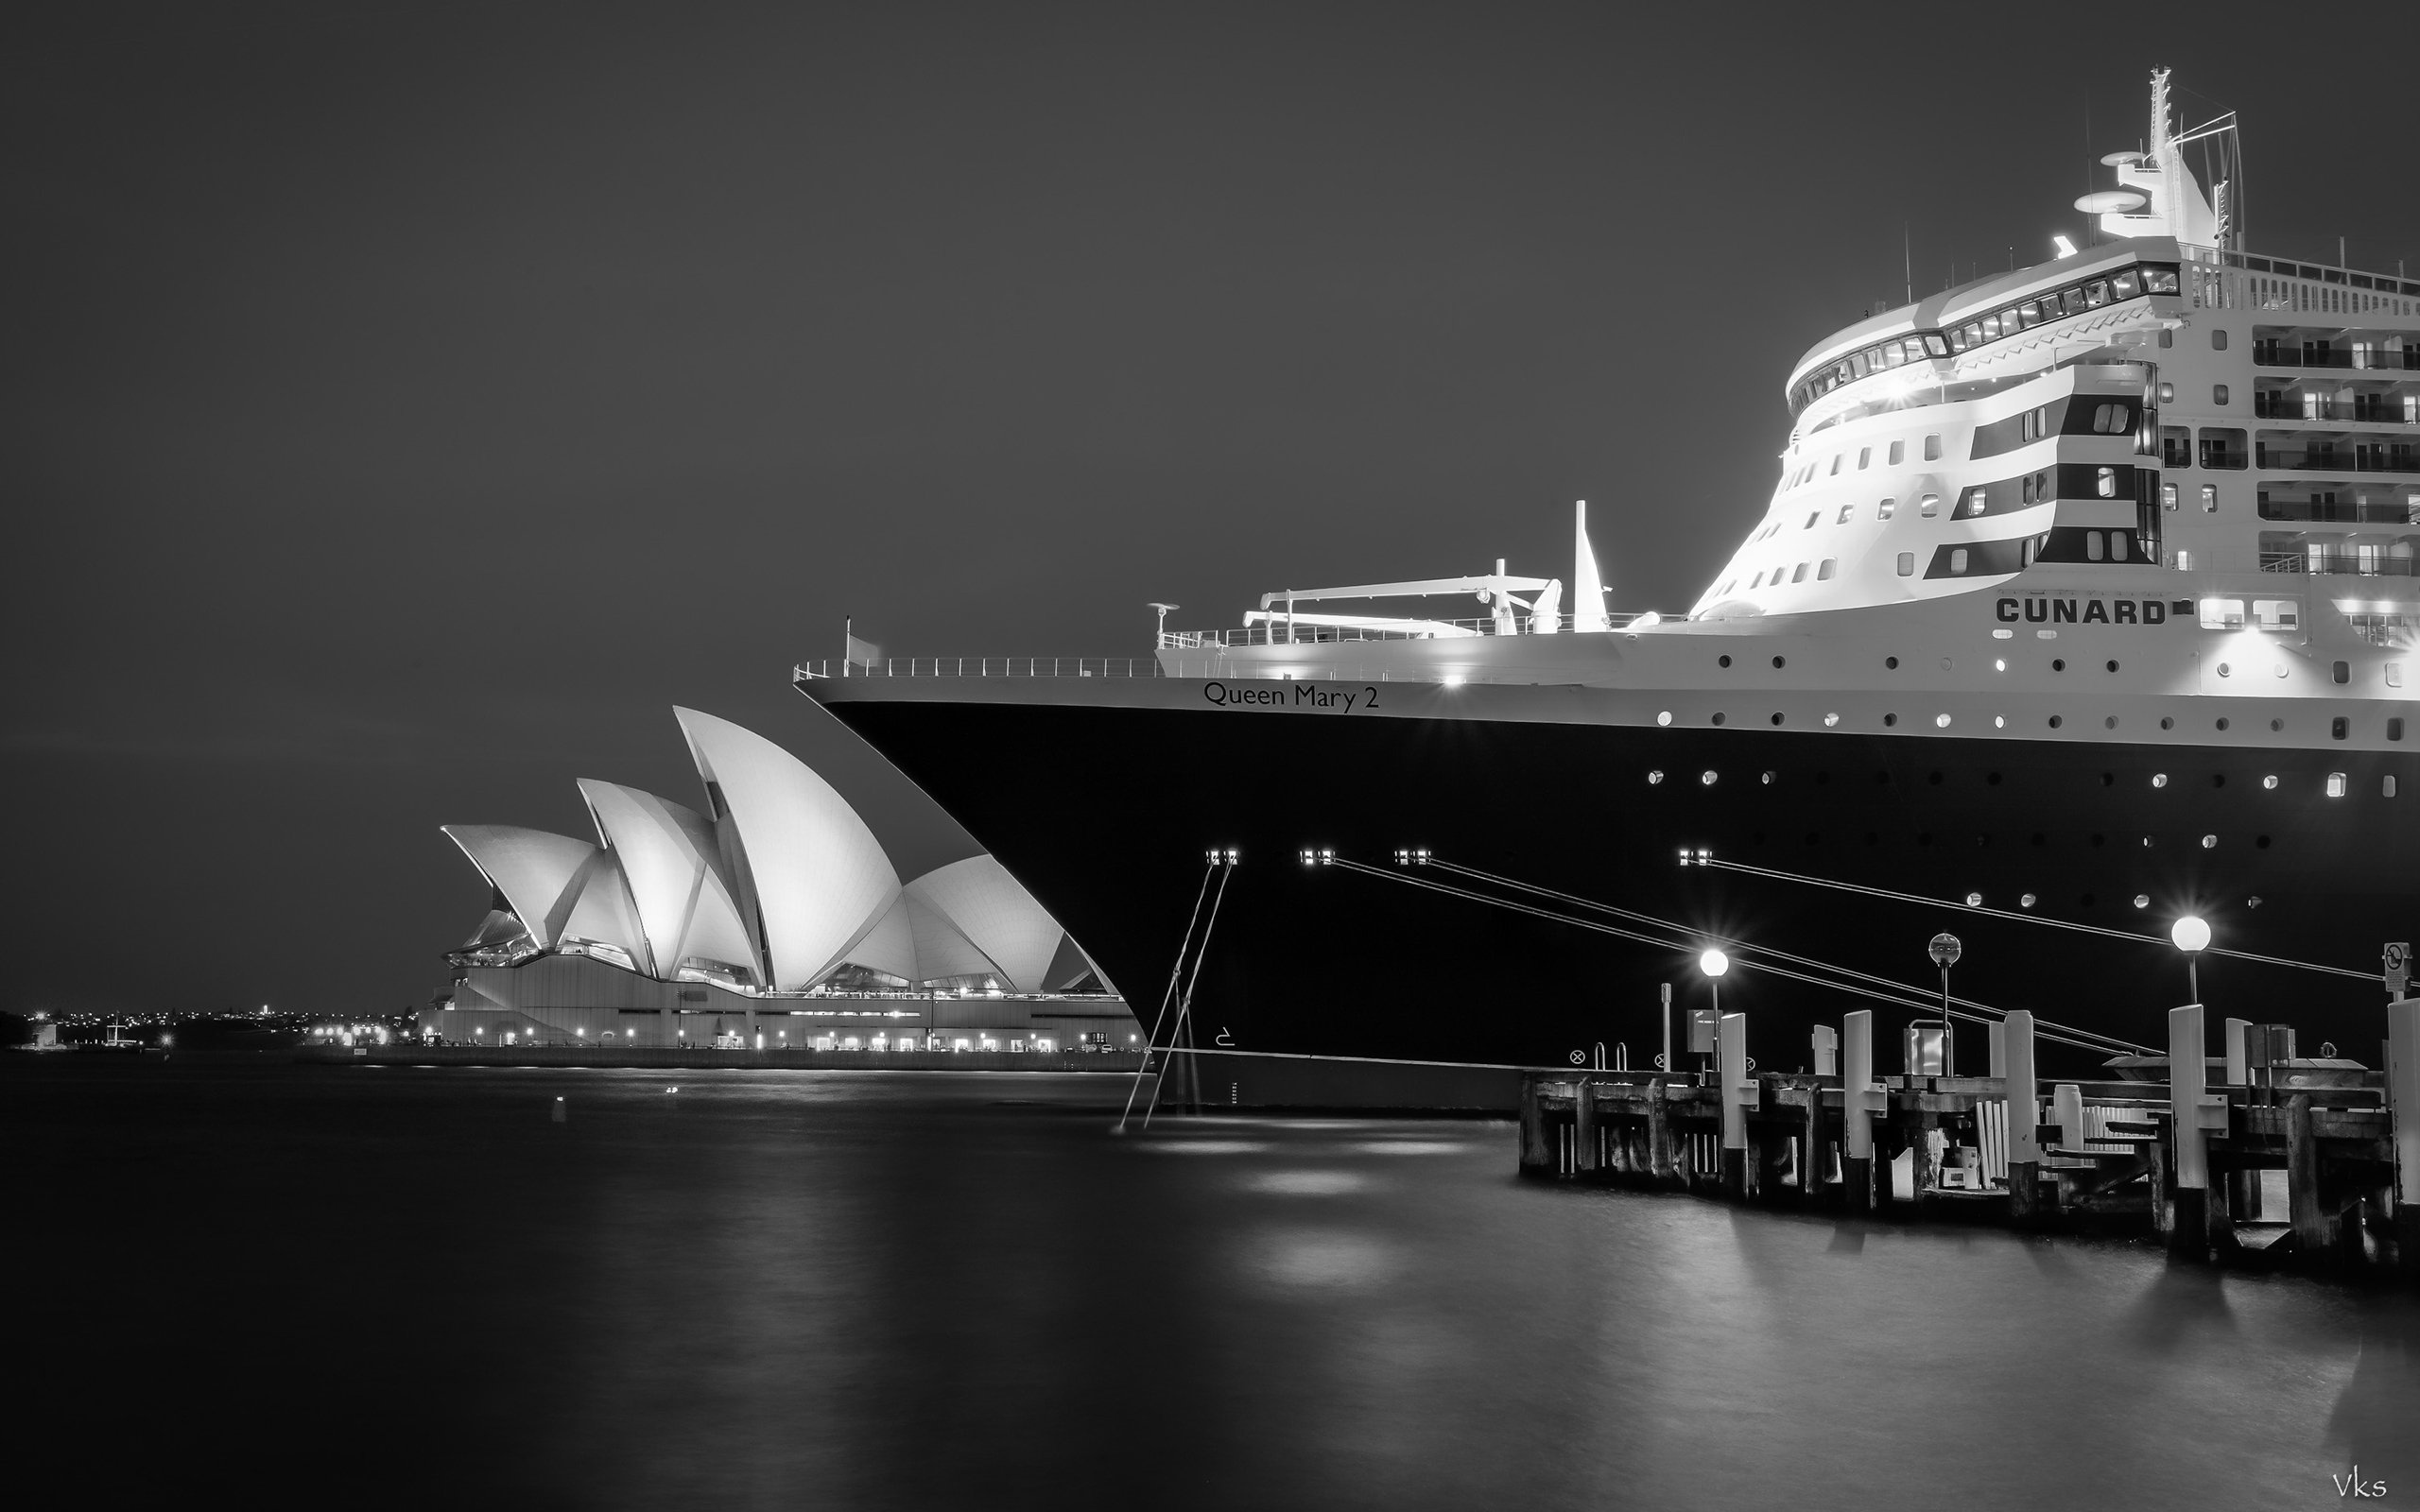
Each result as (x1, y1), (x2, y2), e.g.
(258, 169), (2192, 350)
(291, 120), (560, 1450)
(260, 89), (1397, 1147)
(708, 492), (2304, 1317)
(421, 709), (1140, 1053)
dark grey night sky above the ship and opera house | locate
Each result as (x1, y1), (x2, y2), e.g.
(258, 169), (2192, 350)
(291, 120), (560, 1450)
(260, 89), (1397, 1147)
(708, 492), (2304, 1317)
(0, 5), (2420, 1009)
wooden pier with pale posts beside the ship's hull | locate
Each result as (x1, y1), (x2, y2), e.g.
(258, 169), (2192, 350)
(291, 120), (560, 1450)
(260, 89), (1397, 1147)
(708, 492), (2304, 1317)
(1520, 1004), (2420, 1280)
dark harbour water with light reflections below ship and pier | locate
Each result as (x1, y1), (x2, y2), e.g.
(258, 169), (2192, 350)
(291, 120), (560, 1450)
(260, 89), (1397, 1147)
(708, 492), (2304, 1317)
(0, 1057), (2420, 1509)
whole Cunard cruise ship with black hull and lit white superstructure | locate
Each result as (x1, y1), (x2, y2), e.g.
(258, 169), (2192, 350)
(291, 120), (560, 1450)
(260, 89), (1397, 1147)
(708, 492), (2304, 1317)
(796, 73), (2420, 1070)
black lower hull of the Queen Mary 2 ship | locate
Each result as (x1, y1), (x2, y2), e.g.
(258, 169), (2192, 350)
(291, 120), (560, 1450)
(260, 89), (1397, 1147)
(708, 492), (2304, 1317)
(805, 679), (2420, 1074)
